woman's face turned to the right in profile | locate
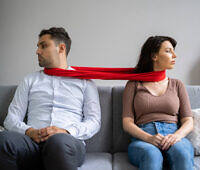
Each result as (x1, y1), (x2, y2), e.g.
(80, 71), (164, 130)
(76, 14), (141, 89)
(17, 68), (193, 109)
(152, 41), (176, 71)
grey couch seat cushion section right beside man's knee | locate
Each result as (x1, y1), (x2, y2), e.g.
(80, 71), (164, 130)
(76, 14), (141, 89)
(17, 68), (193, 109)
(78, 153), (112, 170)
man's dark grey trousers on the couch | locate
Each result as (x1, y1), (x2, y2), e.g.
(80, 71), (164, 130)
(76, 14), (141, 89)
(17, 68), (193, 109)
(0, 131), (86, 170)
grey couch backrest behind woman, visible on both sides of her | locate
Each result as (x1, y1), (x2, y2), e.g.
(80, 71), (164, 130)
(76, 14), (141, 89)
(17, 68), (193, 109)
(112, 86), (200, 153)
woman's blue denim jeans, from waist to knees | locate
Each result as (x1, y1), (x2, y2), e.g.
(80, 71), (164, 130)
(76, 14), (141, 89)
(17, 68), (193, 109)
(128, 122), (194, 170)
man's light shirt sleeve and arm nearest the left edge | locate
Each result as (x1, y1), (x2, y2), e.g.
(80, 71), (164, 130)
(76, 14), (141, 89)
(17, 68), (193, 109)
(4, 78), (30, 134)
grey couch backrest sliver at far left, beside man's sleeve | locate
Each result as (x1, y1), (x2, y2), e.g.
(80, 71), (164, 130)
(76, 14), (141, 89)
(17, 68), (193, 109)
(0, 86), (16, 126)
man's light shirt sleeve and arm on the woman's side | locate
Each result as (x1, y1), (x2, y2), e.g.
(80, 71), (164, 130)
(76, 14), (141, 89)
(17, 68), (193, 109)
(65, 80), (101, 140)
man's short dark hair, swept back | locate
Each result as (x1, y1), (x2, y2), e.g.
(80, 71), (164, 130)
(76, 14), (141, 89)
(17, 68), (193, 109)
(39, 27), (71, 56)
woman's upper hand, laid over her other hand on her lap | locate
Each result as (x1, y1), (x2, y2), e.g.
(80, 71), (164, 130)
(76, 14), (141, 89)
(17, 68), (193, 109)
(161, 133), (181, 150)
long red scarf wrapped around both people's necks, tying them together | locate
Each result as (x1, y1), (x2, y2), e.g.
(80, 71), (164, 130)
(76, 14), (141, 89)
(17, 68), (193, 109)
(44, 66), (166, 81)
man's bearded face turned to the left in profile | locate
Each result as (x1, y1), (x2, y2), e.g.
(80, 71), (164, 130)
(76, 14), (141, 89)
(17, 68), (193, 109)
(36, 34), (59, 68)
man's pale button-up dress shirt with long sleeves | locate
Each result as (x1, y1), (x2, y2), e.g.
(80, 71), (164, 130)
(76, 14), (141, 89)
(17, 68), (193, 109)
(4, 68), (101, 140)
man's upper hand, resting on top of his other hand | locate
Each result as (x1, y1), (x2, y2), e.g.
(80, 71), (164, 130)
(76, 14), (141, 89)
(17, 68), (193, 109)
(39, 126), (69, 142)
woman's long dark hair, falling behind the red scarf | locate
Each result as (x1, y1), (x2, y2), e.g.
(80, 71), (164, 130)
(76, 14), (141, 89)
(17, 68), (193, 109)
(134, 36), (177, 73)
